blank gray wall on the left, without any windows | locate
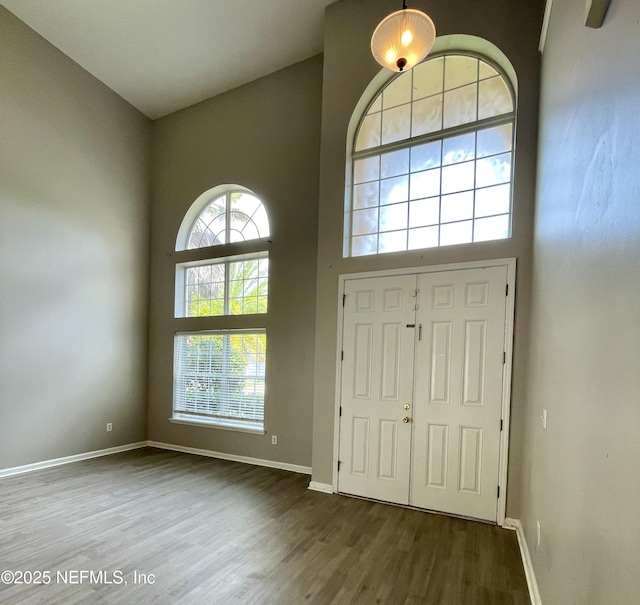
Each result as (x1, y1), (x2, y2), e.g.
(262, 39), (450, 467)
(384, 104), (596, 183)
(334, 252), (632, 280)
(0, 7), (150, 468)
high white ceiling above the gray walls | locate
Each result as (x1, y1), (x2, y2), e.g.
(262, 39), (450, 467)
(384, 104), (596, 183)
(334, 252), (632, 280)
(0, 0), (335, 118)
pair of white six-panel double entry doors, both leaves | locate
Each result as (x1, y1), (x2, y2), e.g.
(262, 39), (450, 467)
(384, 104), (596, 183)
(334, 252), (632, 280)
(338, 266), (507, 522)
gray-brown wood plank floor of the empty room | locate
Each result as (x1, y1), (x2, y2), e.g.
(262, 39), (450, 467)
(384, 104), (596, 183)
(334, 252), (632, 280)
(0, 448), (529, 605)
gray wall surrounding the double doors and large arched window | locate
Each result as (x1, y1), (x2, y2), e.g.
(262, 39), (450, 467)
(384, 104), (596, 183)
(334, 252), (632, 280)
(313, 0), (542, 516)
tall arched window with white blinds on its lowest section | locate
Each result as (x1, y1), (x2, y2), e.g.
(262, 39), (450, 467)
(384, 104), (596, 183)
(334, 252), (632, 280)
(171, 185), (270, 433)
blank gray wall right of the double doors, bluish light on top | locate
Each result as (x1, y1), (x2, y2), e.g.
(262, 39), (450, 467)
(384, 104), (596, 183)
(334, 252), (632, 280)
(522, 0), (640, 605)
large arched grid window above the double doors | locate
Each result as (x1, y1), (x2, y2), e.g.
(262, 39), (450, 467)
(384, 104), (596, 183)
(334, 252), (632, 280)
(345, 54), (515, 256)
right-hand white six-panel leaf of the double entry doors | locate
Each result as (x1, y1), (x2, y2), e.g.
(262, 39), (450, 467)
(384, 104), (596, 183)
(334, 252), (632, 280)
(410, 267), (507, 521)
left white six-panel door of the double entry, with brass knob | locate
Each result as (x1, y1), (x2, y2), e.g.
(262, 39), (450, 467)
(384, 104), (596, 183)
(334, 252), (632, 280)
(338, 275), (416, 504)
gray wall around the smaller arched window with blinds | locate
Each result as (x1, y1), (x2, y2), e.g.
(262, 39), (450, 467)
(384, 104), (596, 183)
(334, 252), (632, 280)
(149, 56), (322, 466)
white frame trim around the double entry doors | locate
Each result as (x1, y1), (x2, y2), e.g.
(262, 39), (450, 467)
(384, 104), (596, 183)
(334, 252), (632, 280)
(332, 258), (516, 527)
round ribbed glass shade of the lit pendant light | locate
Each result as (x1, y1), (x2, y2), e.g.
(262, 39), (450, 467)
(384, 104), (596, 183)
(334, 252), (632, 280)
(371, 8), (436, 71)
